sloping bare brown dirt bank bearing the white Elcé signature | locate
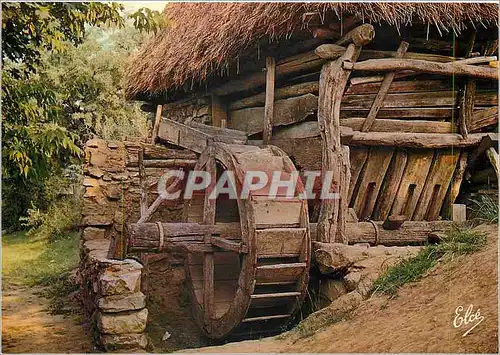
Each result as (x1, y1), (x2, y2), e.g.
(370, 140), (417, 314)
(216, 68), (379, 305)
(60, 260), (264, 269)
(186, 225), (498, 353)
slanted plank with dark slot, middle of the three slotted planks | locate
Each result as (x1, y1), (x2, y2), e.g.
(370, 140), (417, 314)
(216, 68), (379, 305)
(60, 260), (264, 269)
(390, 150), (434, 219)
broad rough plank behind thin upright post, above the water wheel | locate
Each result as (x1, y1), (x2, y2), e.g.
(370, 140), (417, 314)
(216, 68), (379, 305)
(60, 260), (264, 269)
(228, 94), (318, 134)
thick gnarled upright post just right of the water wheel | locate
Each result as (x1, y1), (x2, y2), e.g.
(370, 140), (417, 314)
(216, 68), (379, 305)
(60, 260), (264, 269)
(317, 44), (361, 243)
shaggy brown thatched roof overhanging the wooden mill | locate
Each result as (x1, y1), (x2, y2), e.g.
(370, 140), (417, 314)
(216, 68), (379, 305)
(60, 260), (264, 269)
(127, 2), (498, 97)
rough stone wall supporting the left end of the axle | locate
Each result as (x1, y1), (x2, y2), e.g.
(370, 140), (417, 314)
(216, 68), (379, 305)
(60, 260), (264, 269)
(80, 139), (196, 351)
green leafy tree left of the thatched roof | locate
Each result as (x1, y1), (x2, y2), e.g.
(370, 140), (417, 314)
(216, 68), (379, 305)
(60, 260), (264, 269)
(2, 2), (164, 228)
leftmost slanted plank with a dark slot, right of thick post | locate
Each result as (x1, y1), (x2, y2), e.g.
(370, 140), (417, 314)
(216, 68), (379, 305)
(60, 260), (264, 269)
(353, 147), (394, 219)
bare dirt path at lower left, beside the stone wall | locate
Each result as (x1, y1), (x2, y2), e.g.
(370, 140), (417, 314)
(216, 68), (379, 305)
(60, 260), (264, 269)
(2, 284), (95, 353)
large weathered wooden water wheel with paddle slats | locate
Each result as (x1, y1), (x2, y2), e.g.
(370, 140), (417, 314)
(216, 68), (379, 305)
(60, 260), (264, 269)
(184, 143), (311, 338)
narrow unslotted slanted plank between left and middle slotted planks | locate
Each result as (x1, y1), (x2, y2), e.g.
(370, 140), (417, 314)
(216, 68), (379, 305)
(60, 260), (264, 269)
(372, 149), (408, 221)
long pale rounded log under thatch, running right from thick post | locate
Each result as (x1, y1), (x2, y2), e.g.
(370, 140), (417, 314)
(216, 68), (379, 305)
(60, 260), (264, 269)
(344, 58), (498, 81)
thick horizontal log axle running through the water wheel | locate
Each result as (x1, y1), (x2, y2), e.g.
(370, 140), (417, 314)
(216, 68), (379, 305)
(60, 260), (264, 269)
(125, 221), (452, 253)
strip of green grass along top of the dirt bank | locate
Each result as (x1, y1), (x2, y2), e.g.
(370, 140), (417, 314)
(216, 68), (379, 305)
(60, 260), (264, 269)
(373, 227), (486, 296)
